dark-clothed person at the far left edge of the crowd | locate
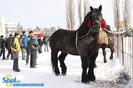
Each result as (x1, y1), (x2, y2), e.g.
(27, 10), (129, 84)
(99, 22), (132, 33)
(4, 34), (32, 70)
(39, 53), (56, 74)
(0, 35), (6, 60)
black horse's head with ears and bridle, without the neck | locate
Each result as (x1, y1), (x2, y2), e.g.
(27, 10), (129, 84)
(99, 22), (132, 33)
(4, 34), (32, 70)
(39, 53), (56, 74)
(90, 5), (102, 33)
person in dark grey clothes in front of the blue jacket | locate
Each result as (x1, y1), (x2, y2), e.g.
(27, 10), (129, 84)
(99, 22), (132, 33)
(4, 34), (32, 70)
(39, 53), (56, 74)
(28, 34), (38, 68)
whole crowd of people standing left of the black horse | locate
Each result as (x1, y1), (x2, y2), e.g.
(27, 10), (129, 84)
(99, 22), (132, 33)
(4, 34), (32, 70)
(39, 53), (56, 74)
(0, 31), (49, 72)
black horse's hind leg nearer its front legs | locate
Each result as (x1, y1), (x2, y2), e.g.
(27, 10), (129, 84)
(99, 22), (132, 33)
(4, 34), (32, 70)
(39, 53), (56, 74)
(59, 53), (67, 75)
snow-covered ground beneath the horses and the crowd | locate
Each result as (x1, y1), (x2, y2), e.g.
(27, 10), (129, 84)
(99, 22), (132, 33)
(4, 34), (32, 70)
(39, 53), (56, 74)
(0, 50), (133, 88)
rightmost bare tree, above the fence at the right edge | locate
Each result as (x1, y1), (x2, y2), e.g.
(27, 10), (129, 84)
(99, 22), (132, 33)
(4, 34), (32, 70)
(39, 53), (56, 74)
(123, 0), (132, 29)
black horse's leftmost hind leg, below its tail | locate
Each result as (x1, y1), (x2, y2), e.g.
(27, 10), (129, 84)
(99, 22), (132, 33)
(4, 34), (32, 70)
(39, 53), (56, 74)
(51, 51), (60, 76)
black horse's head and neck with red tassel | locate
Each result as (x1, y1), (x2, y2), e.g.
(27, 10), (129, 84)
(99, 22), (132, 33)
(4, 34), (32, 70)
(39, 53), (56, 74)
(78, 5), (102, 37)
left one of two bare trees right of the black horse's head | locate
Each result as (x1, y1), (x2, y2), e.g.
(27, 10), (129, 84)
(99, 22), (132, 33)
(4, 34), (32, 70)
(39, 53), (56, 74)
(113, 0), (120, 31)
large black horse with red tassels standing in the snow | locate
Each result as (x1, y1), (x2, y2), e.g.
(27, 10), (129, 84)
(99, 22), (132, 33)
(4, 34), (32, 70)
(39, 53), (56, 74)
(49, 5), (103, 83)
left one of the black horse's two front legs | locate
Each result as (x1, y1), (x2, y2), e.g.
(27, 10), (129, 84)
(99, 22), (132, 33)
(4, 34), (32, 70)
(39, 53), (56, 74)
(81, 56), (89, 83)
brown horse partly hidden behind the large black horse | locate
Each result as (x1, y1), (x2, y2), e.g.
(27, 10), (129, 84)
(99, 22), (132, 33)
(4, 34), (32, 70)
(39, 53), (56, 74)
(100, 25), (114, 63)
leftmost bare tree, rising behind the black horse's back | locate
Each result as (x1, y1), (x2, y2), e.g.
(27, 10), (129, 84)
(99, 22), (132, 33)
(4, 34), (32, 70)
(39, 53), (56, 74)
(66, 0), (75, 30)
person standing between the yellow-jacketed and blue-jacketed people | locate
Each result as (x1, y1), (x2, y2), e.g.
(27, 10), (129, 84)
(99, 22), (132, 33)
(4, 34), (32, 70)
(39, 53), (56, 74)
(19, 35), (26, 60)
